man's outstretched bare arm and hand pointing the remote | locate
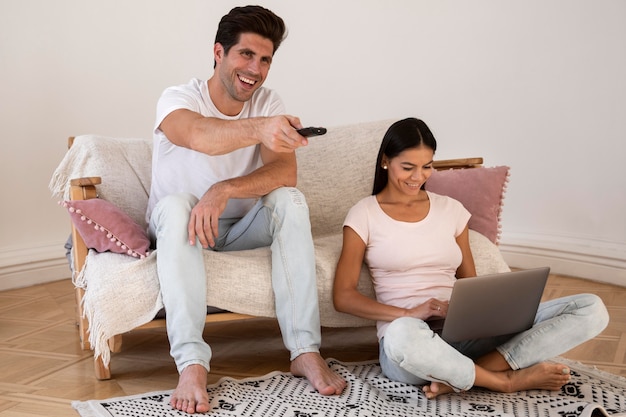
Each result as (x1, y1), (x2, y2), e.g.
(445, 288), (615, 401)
(159, 109), (308, 155)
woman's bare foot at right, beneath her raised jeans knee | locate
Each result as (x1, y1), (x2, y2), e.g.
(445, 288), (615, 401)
(504, 362), (570, 392)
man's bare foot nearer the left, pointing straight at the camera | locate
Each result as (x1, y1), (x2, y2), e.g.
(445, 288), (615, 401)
(170, 365), (209, 414)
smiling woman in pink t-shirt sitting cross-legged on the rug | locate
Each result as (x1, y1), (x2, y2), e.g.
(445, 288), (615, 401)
(333, 118), (608, 398)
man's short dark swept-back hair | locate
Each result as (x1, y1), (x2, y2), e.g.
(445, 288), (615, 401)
(214, 6), (287, 67)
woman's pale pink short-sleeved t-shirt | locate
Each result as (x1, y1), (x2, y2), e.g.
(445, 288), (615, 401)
(344, 192), (470, 338)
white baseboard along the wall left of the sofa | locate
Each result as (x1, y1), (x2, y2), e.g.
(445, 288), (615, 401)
(0, 242), (71, 291)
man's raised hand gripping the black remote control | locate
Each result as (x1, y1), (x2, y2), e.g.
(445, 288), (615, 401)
(253, 115), (309, 152)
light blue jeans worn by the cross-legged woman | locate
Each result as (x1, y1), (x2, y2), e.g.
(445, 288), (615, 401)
(380, 294), (609, 391)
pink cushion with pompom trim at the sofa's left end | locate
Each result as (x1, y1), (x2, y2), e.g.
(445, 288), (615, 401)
(62, 198), (150, 258)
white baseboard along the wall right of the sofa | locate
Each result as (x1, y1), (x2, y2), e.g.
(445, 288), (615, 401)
(500, 233), (626, 287)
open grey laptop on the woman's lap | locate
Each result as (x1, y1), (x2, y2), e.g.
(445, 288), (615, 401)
(429, 267), (550, 342)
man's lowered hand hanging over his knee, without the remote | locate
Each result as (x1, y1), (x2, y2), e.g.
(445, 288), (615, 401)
(187, 182), (228, 249)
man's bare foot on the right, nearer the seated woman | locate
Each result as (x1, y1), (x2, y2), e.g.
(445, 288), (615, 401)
(291, 352), (346, 395)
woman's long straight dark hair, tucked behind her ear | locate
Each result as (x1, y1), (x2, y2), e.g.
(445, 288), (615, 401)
(372, 117), (437, 195)
